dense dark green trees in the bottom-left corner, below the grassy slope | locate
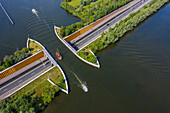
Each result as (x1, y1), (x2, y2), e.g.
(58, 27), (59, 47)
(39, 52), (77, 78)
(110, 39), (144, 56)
(0, 84), (59, 113)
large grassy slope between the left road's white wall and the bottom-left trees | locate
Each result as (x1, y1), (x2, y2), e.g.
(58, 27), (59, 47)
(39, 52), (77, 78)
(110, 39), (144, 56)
(14, 67), (66, 97)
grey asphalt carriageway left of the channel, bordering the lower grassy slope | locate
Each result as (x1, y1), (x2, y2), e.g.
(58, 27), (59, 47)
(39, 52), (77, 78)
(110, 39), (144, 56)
(0, 61), (51, 97)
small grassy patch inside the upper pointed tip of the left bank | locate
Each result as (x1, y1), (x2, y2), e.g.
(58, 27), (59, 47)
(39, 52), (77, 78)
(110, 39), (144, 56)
(29, 40), (43, 54)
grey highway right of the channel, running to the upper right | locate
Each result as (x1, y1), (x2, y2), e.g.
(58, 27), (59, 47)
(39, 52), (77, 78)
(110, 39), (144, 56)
(70, 0), (148, 51)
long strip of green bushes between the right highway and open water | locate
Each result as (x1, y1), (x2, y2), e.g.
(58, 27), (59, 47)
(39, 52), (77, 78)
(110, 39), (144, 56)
(85, 0), (169, 53)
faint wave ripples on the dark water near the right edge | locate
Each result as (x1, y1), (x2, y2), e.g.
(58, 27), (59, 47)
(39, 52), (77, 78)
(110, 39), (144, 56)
(119, 42), (170, 80)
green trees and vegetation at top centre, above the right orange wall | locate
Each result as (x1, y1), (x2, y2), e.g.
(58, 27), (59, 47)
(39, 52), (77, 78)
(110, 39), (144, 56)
(60, 0), (133, 37)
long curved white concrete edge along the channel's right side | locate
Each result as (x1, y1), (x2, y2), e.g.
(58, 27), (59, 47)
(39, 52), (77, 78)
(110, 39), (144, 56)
(54, 26), (100, 68)
